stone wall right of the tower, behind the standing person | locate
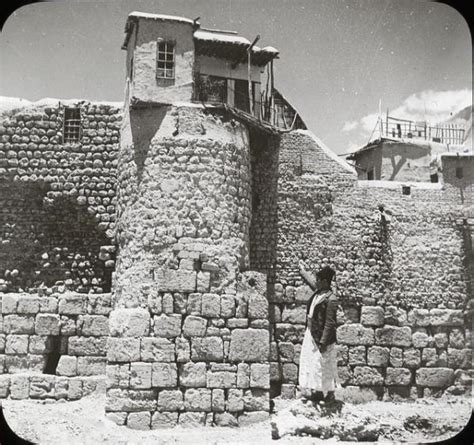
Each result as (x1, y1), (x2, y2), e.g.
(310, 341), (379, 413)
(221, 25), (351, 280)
(269, 132), (471, 397)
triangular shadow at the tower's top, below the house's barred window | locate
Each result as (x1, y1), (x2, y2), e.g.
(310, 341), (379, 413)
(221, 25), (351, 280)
(130, 106), (169, 183)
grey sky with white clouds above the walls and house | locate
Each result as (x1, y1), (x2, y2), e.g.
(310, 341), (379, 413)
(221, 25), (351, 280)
(0, 0), (472, 154)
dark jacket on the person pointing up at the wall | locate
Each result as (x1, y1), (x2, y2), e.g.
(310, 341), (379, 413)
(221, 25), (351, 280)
(301, 272), (339, 346)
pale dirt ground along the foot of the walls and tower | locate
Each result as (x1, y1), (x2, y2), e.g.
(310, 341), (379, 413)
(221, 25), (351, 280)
(3, 393), (472, 445)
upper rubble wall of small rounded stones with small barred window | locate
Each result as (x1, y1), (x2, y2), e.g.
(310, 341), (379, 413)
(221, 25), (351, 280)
(0, 101), (121, 293)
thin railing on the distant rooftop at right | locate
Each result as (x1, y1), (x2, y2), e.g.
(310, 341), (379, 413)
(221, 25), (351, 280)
(379, 115), (465, 145)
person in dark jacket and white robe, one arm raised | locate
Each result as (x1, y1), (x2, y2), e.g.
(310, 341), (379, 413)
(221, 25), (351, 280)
(298, 260), (338, 404)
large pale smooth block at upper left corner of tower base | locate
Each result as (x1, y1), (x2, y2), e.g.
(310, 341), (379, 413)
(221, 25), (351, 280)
(109, 308), (150, 337)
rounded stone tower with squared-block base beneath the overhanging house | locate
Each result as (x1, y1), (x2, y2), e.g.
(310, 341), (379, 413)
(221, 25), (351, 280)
(106, 107), (270, 429)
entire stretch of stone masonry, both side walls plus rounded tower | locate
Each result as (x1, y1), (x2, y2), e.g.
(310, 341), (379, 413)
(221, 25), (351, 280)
(0, 102), (473, 429)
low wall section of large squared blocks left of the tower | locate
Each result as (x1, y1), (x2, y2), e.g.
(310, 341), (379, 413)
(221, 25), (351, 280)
(0, 292), (111, 400)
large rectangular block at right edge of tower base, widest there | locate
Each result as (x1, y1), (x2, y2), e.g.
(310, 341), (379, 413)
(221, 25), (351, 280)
(229, 329), (270, 362)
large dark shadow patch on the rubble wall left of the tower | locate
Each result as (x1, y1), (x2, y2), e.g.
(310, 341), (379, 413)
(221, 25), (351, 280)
(0, 182), (113, 293)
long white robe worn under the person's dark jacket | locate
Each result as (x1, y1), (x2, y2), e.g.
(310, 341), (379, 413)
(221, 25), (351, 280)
(298, 293), (339, 395)
